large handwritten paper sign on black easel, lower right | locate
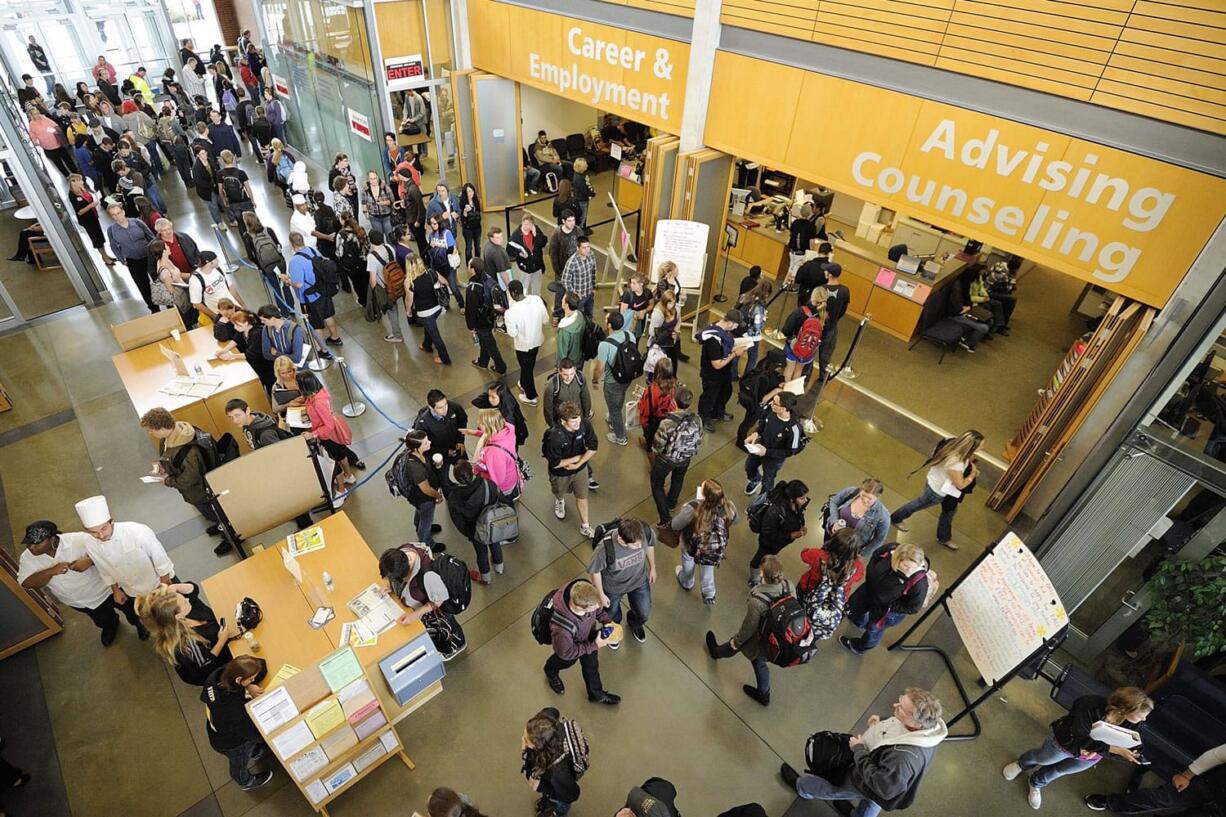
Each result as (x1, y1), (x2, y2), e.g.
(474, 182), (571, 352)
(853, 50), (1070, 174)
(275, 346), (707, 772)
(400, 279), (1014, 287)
(948, 534), (1068, 683)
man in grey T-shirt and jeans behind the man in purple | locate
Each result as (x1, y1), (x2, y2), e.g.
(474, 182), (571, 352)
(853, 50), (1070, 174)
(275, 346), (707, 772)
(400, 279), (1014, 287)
(587, 516), (656, 650)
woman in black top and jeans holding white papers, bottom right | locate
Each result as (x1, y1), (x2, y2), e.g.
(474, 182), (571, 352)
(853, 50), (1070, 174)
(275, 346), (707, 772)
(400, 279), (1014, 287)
(1002, 687), (1154, 808)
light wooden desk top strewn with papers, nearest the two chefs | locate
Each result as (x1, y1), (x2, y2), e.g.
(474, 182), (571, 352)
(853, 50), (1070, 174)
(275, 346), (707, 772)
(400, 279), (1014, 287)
(201, 510), (443, 724)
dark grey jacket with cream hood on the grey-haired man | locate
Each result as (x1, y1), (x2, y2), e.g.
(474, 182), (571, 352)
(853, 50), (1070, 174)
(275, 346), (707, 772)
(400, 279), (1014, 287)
(850, 718), (949, 811)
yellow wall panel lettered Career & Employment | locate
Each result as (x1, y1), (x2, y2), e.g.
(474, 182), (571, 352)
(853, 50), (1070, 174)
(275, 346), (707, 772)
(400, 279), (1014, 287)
(468, 0), (689, 134)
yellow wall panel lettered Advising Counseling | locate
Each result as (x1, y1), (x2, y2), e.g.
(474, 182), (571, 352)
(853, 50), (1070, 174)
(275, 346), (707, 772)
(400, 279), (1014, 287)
(705, 52), (1226, 305)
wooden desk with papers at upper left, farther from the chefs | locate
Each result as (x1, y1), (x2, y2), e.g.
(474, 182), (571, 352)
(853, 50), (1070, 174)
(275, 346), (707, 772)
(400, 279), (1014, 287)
(110, 326), (272, 451)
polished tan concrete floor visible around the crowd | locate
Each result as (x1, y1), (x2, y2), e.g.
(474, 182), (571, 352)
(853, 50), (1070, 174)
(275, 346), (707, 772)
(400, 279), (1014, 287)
(0, 149), (1123, 817)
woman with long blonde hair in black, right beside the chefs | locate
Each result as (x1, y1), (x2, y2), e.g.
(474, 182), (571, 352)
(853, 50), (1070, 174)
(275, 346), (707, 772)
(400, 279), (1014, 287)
(136, 581), (238, 687)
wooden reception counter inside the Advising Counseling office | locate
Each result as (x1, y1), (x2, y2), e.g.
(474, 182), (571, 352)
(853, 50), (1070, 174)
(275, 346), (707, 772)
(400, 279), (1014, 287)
(728, 212), (966, 342)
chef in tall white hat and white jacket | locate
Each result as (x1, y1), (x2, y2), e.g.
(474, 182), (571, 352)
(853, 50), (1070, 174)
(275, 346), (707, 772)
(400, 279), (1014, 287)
(76, 497), (178, 640)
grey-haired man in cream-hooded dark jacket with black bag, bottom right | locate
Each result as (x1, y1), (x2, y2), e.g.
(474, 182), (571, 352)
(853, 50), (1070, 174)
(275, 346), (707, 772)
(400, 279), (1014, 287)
(780, 687), (949, 817)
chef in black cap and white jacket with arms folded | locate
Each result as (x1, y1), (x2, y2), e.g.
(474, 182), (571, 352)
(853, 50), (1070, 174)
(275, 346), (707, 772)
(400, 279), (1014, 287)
(17, 519), (123, 646)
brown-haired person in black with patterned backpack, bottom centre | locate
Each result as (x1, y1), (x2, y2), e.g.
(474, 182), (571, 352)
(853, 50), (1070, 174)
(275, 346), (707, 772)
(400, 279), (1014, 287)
(522, 707), (587, 817)
